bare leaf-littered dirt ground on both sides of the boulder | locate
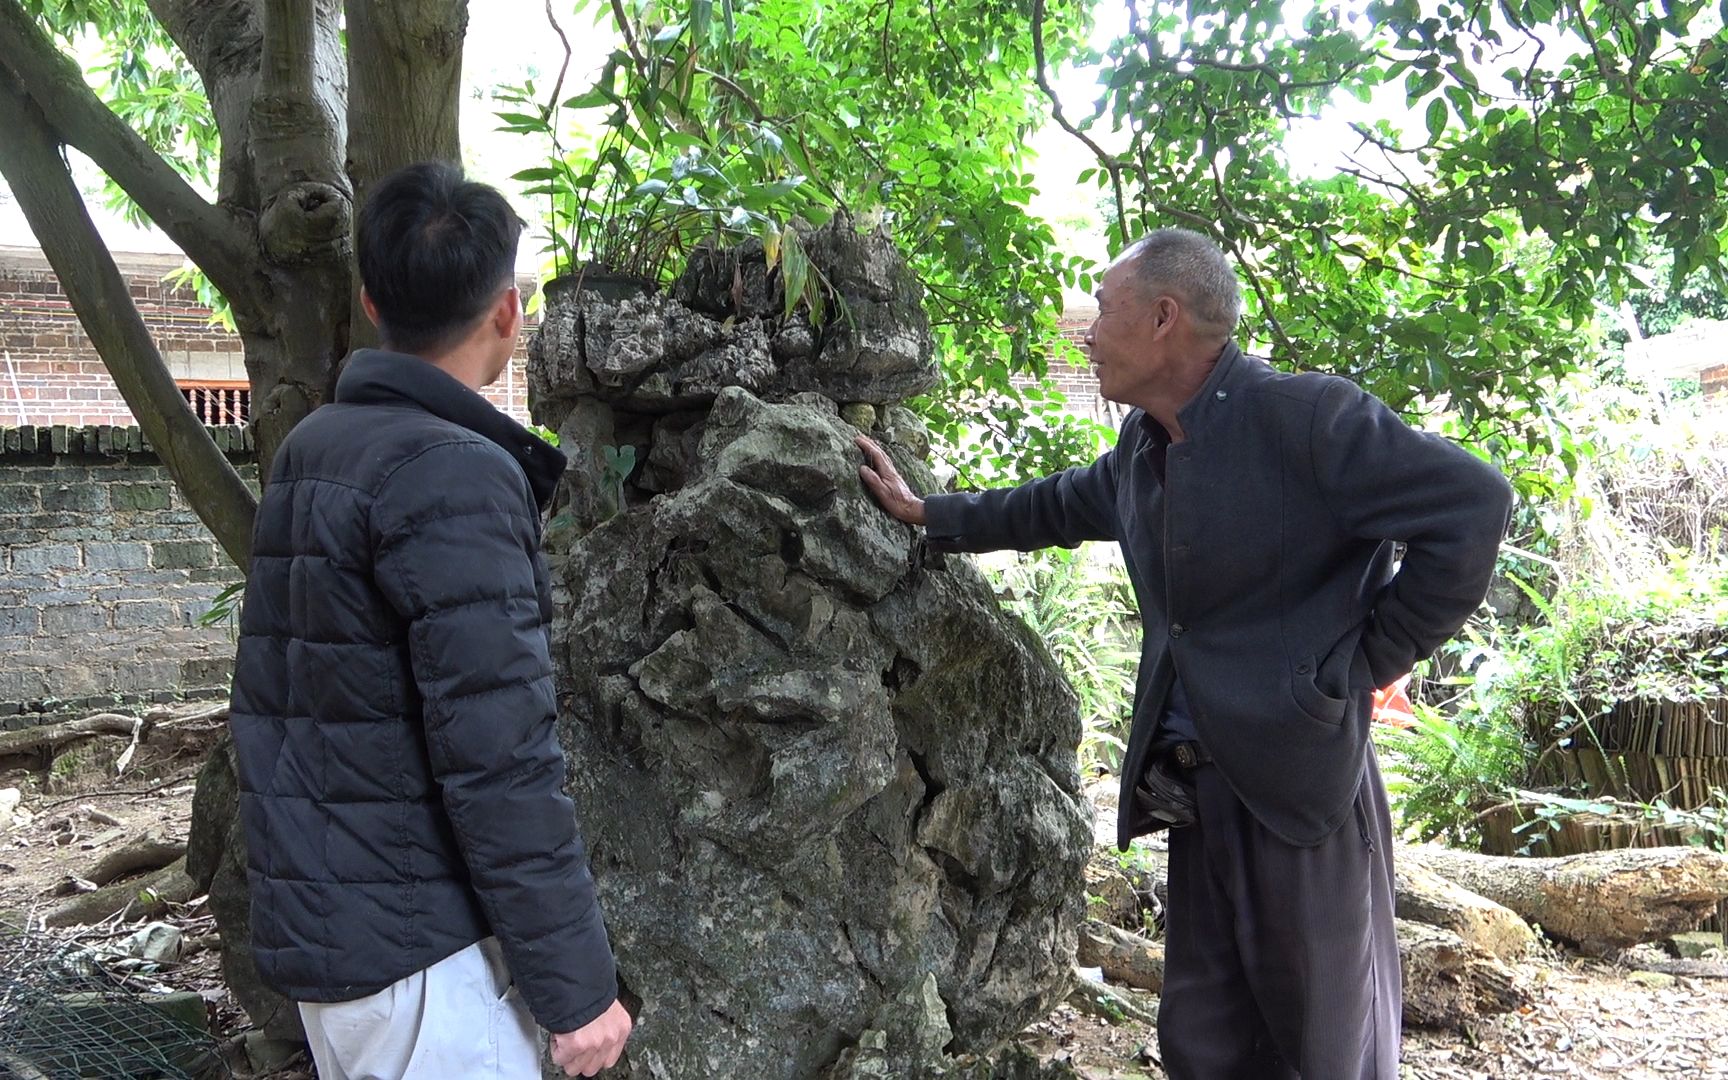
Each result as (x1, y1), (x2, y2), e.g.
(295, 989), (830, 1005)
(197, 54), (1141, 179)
(0, 731), (1728, 1080)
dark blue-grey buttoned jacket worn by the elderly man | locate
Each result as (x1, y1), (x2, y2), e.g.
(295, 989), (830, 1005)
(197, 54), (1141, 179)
(926, 346), (1512, 847)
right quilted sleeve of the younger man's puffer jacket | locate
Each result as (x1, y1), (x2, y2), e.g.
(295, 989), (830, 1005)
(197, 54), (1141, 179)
(373, 441), (617, 1032)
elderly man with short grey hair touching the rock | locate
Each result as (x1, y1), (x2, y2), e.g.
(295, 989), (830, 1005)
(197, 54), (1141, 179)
(859, 228), (1512, 1080)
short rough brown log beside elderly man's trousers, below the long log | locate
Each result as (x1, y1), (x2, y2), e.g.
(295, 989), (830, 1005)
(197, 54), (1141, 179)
(1398, 919), (1531, 1028)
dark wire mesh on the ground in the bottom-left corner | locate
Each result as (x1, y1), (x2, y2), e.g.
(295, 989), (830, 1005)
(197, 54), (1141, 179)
(0, 924), (232, 1080)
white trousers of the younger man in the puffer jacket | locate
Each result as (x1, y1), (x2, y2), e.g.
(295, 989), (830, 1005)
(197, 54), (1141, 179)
(299, 938), (541, 1080)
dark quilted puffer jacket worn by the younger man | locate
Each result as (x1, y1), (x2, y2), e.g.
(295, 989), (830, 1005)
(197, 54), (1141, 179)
(230, 351), (617, 1032)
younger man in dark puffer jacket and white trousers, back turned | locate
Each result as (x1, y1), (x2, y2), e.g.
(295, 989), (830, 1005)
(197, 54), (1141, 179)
(230, 164), (631, 1080)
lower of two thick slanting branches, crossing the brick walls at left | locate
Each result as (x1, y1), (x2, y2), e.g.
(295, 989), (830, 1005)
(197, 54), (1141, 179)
(0, 71), (257, 569)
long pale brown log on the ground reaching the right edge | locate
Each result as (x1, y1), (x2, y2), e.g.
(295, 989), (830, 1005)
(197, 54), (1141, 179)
(1398, 847), (1728, 952)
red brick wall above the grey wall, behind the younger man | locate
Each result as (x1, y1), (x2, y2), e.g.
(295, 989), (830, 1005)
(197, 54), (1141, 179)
(0, 247), (532, 427)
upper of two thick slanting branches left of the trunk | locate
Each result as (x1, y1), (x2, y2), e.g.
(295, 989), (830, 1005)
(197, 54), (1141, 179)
(0, 0), (254, 309)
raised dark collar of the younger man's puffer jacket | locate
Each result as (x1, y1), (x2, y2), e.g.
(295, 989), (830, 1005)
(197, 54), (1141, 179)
(335, 349), (565, 510)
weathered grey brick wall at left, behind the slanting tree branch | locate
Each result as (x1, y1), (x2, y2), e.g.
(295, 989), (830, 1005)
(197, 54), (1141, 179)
(0, 427), (257, 729)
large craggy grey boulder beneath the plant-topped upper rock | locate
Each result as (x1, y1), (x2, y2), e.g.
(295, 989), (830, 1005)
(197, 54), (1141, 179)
(553, 389), (1090, 1080)
